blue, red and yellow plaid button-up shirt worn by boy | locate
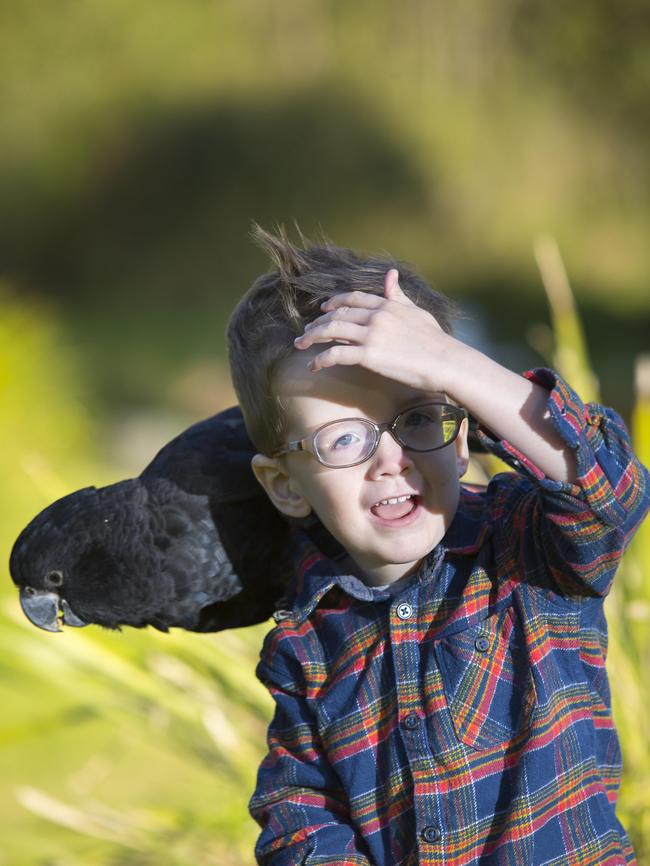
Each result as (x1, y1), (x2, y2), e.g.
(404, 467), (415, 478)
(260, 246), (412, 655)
(250, 370), (650, 866)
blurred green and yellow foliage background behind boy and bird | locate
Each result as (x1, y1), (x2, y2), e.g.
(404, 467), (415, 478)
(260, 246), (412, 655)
(0, 0), (650, 866)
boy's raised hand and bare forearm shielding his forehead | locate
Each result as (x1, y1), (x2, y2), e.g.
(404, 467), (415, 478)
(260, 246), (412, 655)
(294, 269), (576, 481)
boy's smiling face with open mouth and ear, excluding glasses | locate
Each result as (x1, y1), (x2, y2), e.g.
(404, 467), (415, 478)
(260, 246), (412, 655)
(254, 346), (468, 584)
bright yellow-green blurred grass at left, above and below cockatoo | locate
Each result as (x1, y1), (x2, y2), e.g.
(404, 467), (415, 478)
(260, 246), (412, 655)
(0, 287), (270, 866)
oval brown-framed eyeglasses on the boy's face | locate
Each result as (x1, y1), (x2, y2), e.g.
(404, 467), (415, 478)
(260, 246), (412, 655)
(272, 403), (467, 469)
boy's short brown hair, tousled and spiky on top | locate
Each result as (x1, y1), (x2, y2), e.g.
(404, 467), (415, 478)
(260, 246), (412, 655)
(227, 225), (456, 455)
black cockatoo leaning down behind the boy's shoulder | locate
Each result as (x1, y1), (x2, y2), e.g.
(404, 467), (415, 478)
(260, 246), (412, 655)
(9, 407), (341, 632)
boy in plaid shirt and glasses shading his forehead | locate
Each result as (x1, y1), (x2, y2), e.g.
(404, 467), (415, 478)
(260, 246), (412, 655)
(228, 230), (649, 866)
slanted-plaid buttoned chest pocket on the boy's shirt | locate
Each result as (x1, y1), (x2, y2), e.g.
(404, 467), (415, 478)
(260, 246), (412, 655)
(435, 608), (536, 750)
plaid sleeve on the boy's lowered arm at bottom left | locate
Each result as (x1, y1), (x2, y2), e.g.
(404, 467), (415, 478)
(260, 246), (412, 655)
(249, 630), (371, 866)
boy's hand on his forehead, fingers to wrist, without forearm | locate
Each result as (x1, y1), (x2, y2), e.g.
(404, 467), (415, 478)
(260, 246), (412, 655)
(294, 268), (457, 391)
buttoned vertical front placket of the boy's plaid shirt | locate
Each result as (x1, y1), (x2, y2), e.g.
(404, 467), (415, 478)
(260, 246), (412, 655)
(390, 587), (445, 866)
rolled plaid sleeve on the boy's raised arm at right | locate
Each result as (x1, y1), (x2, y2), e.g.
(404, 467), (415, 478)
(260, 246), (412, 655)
(477, 369), (650, 596)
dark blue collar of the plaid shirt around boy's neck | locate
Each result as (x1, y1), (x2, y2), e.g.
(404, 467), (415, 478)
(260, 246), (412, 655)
(288, 485), (488, 622)
